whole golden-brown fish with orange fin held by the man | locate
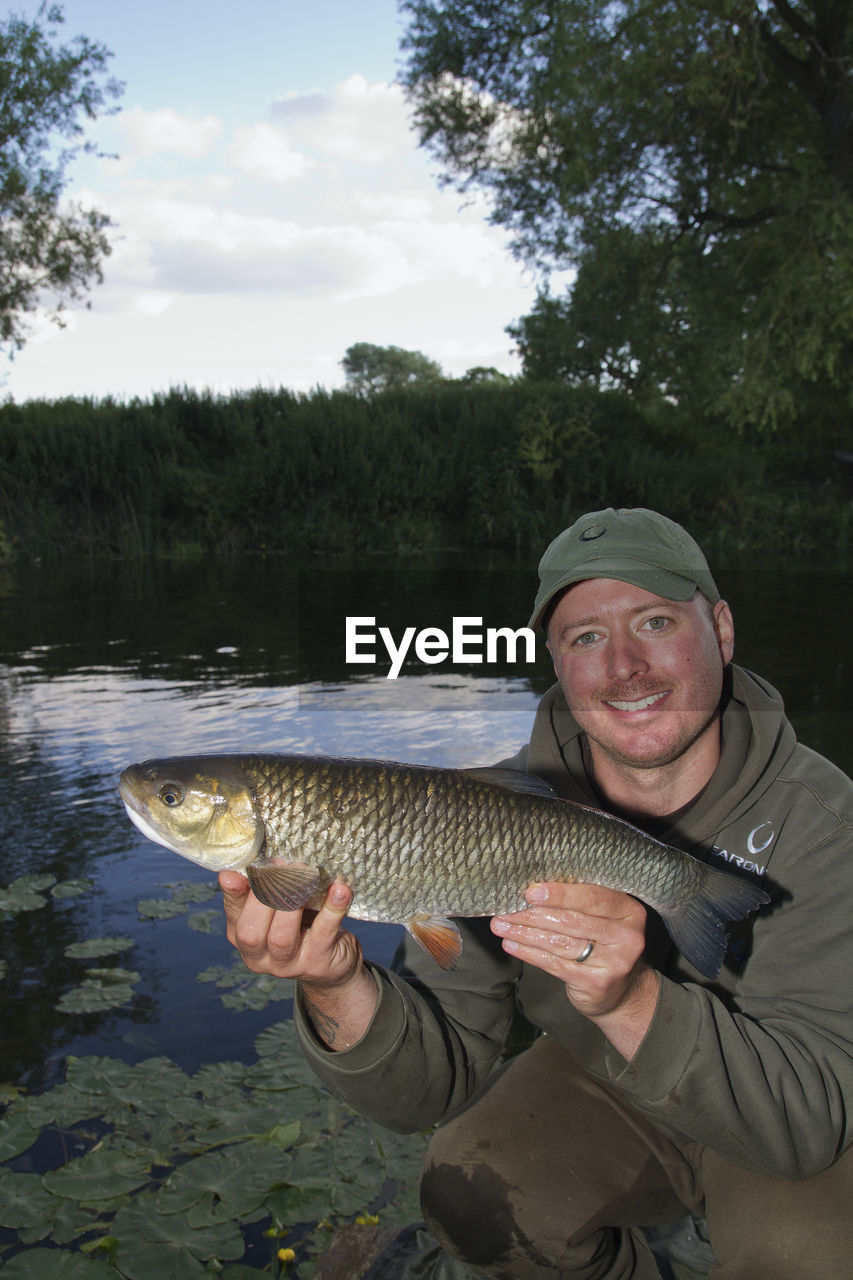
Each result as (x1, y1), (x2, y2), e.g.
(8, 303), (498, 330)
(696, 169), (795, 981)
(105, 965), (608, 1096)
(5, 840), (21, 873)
(119, 754), (770, 978)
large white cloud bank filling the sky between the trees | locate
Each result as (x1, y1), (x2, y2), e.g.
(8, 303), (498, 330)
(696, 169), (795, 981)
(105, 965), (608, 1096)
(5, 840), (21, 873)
(10, 63), (532, 396)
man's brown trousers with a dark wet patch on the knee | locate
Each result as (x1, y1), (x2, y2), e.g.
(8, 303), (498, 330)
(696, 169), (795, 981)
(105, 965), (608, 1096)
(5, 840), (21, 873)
(421, 1036), (853, 1280)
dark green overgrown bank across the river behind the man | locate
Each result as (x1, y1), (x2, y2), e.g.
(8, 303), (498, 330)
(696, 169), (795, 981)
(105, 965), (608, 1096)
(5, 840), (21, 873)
(0, 381), (853, 559)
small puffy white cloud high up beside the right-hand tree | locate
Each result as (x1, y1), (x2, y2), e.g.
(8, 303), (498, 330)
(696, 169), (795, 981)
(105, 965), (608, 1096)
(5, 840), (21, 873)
(270, 76), (414, 164)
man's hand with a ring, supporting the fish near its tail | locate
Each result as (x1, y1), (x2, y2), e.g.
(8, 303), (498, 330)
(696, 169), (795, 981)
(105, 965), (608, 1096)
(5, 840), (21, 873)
(492, 883), (660, 1060)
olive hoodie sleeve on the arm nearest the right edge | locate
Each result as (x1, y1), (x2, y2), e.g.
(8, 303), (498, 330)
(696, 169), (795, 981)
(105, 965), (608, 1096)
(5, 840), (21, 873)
(584, 774), (853, 1178)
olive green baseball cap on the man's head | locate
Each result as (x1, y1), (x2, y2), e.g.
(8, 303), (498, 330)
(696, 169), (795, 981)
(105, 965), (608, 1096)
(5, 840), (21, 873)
(528, 507), (720, 628)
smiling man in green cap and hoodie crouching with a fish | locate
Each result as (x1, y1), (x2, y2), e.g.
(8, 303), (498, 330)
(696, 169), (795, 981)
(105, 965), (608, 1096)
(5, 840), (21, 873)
(222, 509), (853, 1280)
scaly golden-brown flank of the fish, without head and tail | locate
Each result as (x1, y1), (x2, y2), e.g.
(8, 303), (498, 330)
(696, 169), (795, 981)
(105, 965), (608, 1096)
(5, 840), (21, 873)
(239, 763), (695, 920)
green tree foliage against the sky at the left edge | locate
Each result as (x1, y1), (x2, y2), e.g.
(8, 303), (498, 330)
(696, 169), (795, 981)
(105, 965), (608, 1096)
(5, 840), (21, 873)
(0, 4), (122, 353)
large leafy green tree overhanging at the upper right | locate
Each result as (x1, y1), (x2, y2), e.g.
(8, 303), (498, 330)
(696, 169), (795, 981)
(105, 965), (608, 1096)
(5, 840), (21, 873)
(403, 0), (853, 435)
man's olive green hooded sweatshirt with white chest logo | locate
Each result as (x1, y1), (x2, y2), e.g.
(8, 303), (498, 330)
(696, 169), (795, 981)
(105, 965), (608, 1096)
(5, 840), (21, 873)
(295, 666), (853, 1178)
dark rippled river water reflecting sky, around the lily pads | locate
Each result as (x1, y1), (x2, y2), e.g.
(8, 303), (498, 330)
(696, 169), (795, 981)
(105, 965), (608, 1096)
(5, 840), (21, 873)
(0, 556), (853, 1088)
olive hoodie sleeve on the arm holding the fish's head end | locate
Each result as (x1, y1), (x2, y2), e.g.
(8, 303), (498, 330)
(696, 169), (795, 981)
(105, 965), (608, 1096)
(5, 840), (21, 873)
(293, 920), (520, 1133)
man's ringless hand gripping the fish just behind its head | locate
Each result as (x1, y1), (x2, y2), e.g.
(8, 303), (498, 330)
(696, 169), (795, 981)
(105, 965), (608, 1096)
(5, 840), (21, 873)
(219, 872), (377, 1050)
